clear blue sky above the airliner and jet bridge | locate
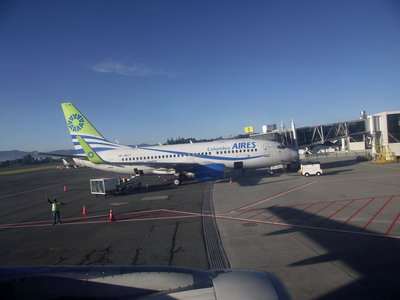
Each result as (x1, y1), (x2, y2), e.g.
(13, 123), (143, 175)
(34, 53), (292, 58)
(0, 0), (400, 151)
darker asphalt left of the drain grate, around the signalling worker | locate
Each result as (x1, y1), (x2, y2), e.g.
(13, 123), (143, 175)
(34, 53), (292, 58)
(0, 168), (209, 269)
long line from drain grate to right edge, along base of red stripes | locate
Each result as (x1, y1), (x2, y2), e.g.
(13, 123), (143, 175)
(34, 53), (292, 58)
(215, 216), (400, 240)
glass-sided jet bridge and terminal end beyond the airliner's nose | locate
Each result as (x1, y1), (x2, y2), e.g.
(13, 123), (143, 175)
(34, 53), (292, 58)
(251, 111), (400, 159)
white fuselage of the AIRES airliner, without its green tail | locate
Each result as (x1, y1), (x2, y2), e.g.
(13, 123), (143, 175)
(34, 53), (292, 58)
(75, 139), (298, 174)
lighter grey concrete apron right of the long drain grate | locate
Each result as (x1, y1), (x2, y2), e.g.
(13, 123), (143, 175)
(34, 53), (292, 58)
(214, 160), (400, 299)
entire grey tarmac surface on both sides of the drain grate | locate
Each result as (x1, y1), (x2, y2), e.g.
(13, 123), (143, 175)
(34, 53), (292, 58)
(0, 159), (400, 299)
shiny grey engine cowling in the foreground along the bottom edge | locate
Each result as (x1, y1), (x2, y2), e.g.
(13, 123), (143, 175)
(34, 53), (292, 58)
(0, 266), (290, 300)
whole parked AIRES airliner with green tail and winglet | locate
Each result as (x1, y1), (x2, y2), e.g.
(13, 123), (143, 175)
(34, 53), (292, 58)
(61, 103), (298, 185)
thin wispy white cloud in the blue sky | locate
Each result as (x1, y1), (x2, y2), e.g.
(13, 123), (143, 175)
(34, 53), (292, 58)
(91, 59), (174, 77)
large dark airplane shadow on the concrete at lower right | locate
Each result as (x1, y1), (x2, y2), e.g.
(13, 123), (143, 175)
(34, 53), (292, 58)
(265, 206), (400, 300)
